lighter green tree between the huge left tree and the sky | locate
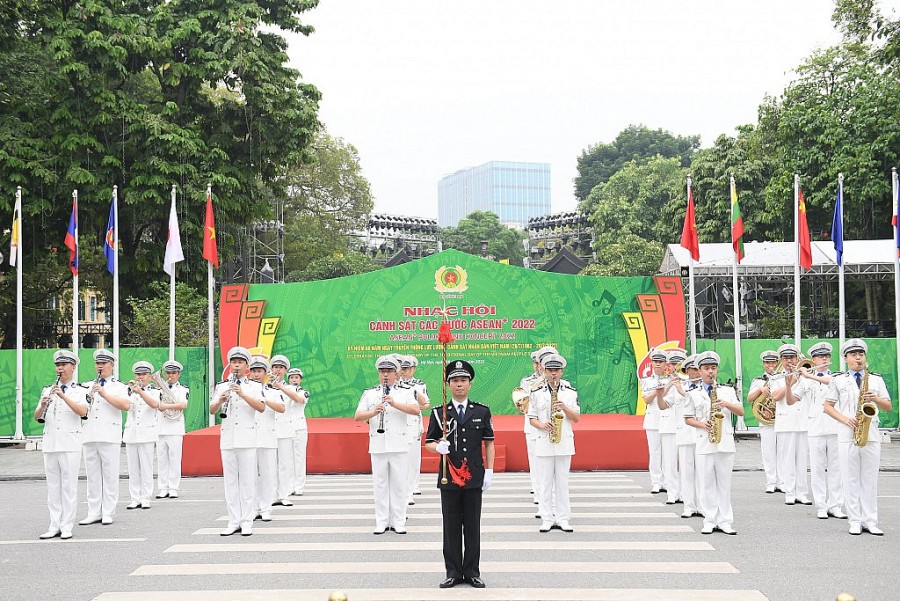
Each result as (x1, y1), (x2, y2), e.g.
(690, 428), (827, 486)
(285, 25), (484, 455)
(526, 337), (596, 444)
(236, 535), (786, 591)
(284, 129), (374, 272)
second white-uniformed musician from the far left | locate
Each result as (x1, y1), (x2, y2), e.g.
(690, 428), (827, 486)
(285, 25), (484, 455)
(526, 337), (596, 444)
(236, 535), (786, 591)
(78, 349), (131, 526)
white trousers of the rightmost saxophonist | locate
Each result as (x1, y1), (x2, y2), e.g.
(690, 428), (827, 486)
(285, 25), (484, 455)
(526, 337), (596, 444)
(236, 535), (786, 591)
(838, 440), (881, 526)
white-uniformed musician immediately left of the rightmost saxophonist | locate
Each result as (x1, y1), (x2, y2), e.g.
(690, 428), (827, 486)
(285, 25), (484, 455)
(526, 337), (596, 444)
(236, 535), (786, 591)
(800, 342), (847, 520)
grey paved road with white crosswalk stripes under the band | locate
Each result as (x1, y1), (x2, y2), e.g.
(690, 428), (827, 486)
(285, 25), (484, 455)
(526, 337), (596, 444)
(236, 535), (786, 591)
(0, 440), (900, 601)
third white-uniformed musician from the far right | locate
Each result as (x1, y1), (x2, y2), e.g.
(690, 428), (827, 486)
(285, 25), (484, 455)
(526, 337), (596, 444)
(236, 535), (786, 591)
(772, 344), (812, 505)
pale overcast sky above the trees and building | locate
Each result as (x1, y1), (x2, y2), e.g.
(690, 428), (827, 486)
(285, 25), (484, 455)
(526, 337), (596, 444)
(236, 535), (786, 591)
(288, 0), (900, 218)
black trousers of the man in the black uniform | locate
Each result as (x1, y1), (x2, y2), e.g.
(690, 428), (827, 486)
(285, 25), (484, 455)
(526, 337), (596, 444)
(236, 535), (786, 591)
(441, 487), (481, 578)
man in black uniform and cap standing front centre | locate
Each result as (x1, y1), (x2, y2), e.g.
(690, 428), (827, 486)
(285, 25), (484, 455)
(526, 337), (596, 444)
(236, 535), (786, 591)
(425, 361), (494, 588)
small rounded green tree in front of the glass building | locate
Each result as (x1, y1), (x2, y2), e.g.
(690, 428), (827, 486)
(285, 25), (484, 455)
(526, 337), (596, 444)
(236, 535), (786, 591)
(438, 211), (525, 266)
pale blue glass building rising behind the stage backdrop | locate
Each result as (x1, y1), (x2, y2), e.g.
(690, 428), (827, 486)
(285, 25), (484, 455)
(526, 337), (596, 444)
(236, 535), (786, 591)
(438, 161), (550, 229)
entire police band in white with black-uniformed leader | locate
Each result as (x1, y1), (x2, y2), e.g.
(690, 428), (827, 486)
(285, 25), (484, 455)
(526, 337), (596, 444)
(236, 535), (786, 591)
(34, 339), (891, 588)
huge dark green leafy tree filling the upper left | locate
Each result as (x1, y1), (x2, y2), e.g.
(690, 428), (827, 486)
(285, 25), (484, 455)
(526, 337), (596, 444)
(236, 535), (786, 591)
(0, 0), (319, 345)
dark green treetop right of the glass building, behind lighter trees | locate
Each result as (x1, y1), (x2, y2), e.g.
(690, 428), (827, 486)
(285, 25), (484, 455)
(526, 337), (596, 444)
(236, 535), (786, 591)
(575, 125), (700, 203)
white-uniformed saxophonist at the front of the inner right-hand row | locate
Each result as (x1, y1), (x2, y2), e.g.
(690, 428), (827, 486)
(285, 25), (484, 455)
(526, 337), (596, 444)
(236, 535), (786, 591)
(684, 351), (744, 534)
